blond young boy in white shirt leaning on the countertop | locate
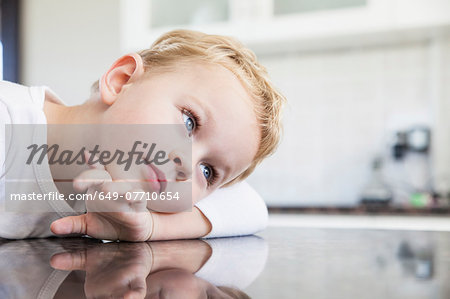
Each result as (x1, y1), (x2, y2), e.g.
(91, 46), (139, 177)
(0, 30), (285, 241)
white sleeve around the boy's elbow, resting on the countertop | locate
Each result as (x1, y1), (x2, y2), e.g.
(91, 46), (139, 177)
(196, 182), (268, 238)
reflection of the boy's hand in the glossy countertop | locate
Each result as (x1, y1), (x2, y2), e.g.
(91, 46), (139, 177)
(50, 242), (153, 298)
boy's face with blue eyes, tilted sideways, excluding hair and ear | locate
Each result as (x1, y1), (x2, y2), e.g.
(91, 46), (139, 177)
(101, 62), (260, 203)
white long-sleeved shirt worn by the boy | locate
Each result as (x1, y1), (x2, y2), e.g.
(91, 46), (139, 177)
(0, 81), (268, 239)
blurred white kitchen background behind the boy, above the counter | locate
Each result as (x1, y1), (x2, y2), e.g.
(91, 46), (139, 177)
(1, 0), (450, 214)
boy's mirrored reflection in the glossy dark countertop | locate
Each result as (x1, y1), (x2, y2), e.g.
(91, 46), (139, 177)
(0, 236), (267, 299)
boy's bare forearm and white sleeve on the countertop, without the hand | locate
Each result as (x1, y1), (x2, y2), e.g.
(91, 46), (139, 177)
(151, 182), (268, 240)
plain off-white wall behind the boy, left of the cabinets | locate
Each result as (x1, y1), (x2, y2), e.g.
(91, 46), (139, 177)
(21, 0), (121, 104)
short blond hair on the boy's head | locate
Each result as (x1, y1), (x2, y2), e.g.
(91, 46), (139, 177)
(93, 30), (286, 186)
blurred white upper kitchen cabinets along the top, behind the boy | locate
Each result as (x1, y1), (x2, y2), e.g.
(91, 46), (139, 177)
(120, 0), (450, 53)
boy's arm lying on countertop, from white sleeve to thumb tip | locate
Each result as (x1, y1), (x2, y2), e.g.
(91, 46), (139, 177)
(52, 182), (268, 241)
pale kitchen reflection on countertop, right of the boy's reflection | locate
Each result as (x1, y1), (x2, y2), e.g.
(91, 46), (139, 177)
(245, 227), (450, 299)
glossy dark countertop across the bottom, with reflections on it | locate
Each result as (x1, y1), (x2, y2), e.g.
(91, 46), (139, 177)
(0, 227), (450, 299)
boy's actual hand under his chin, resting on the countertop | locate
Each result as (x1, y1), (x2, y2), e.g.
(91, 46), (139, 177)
(50, 159), (153, 241)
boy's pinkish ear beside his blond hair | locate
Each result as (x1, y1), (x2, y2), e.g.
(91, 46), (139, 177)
(99, 53), (144, 105)
